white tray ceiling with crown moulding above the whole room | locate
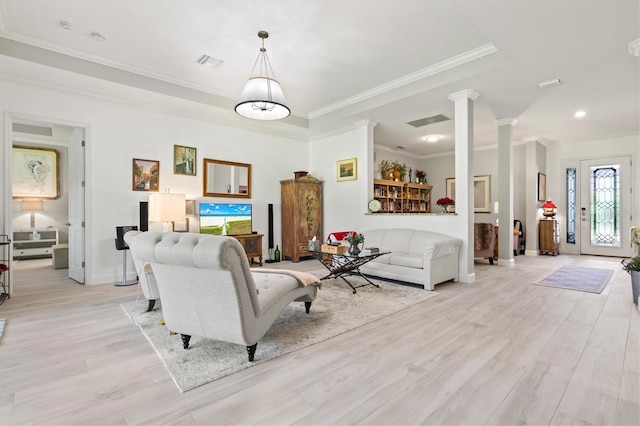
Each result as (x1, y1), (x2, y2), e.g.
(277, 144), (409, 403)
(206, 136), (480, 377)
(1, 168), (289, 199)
(0, 0), (640, 156)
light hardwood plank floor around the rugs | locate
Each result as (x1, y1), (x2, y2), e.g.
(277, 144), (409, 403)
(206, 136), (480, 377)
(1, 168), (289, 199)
(0, 255), (640, 425)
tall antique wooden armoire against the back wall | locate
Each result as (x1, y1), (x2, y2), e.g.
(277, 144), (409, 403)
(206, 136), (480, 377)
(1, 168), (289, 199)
(280, 175), (324, 262)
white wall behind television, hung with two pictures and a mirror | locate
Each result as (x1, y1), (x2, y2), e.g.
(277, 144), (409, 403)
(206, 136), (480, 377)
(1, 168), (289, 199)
(0, 76), (310, 284)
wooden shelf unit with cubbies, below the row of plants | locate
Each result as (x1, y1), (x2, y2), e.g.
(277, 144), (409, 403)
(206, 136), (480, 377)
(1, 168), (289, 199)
(373, 179), (432, 213)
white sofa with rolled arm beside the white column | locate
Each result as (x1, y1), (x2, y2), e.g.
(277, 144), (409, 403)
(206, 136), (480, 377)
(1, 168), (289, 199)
(360, 229), (462, 290)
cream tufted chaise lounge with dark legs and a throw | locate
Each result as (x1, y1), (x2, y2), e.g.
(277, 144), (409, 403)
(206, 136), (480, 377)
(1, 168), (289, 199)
(125, 231), (320, 361)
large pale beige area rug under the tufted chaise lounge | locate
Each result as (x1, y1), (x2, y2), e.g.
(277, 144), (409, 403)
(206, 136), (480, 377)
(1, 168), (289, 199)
(122, 277), (438, 392)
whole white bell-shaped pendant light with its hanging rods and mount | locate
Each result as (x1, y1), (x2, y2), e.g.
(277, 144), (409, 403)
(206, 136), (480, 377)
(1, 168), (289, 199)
(236, 31), (291, 120)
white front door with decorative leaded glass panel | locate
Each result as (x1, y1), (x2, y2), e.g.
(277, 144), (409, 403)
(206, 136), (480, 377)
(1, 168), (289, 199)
(578, 156), (631, 257)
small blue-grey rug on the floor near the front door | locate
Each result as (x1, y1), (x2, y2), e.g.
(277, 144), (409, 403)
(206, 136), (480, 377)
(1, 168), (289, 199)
(536, 266), (613, 293)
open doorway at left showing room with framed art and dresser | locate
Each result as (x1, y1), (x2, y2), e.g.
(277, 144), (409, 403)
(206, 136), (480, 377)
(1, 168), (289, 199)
(6, 116), (84, 283)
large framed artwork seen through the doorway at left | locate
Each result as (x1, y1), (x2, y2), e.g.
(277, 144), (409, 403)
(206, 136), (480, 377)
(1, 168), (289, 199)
(11, 146), (60, 200)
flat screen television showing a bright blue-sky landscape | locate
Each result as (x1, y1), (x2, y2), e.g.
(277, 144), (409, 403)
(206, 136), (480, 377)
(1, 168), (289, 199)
(200, 203), (252, 235)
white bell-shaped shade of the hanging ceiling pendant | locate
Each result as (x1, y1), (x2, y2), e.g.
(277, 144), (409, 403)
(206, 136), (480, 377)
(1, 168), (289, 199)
(236, 77), (291, 120)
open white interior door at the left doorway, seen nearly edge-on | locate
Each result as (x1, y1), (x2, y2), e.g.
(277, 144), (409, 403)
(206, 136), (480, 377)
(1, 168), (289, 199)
(69, 129), (84, 284)
